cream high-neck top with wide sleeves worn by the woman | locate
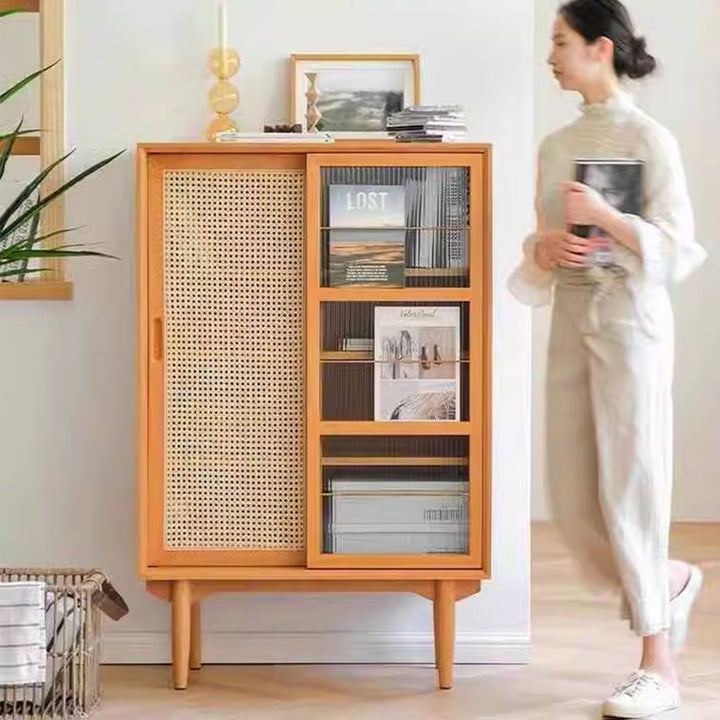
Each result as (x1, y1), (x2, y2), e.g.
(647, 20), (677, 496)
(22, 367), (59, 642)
(508, 91), (707, 305)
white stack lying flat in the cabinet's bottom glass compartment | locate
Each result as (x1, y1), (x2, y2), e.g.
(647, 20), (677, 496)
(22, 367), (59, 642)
(325, 475), (468, 554)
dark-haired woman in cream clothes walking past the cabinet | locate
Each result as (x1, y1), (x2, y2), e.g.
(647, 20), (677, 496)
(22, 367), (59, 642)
(509, 0), (706, 718)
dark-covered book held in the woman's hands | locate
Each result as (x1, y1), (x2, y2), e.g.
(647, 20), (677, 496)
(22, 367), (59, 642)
(571, 159), (644, 266)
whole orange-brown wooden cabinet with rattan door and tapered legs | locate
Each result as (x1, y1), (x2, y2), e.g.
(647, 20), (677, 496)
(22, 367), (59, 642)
(137, 139), (492, 688)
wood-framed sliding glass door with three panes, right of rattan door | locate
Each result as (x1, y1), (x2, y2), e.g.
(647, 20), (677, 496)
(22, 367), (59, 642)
(306, 153), (485, 568)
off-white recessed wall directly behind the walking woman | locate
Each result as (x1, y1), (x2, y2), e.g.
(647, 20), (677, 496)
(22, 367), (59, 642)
(532, 0), (720, 520)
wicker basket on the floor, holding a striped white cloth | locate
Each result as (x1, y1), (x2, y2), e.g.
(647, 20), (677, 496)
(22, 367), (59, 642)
(0, 568), (106, 720)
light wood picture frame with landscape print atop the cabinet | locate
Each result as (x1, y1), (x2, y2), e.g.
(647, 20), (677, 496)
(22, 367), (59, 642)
(290, 53), (420, 137)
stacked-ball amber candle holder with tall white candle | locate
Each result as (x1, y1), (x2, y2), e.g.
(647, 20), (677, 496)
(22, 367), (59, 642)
(205, 0), (240, 142)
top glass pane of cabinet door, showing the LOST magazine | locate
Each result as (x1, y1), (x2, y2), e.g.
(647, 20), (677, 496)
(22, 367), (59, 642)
(320, 166), (469, 288)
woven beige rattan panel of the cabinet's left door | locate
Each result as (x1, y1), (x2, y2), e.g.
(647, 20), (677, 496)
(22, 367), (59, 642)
(164, 170), (304, 550)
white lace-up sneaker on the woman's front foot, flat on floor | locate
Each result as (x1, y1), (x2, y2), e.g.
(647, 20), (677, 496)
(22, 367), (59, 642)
(603, 670), (680, 718)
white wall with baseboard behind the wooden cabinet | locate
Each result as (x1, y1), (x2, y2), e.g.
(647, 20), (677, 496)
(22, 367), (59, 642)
(0, 0), (534, 662)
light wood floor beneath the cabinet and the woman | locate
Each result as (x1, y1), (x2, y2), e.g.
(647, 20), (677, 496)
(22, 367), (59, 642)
(95, 524), (720, 720)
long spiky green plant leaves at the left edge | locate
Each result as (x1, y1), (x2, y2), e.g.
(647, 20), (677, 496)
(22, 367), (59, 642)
(0, 10), (124, 282)
